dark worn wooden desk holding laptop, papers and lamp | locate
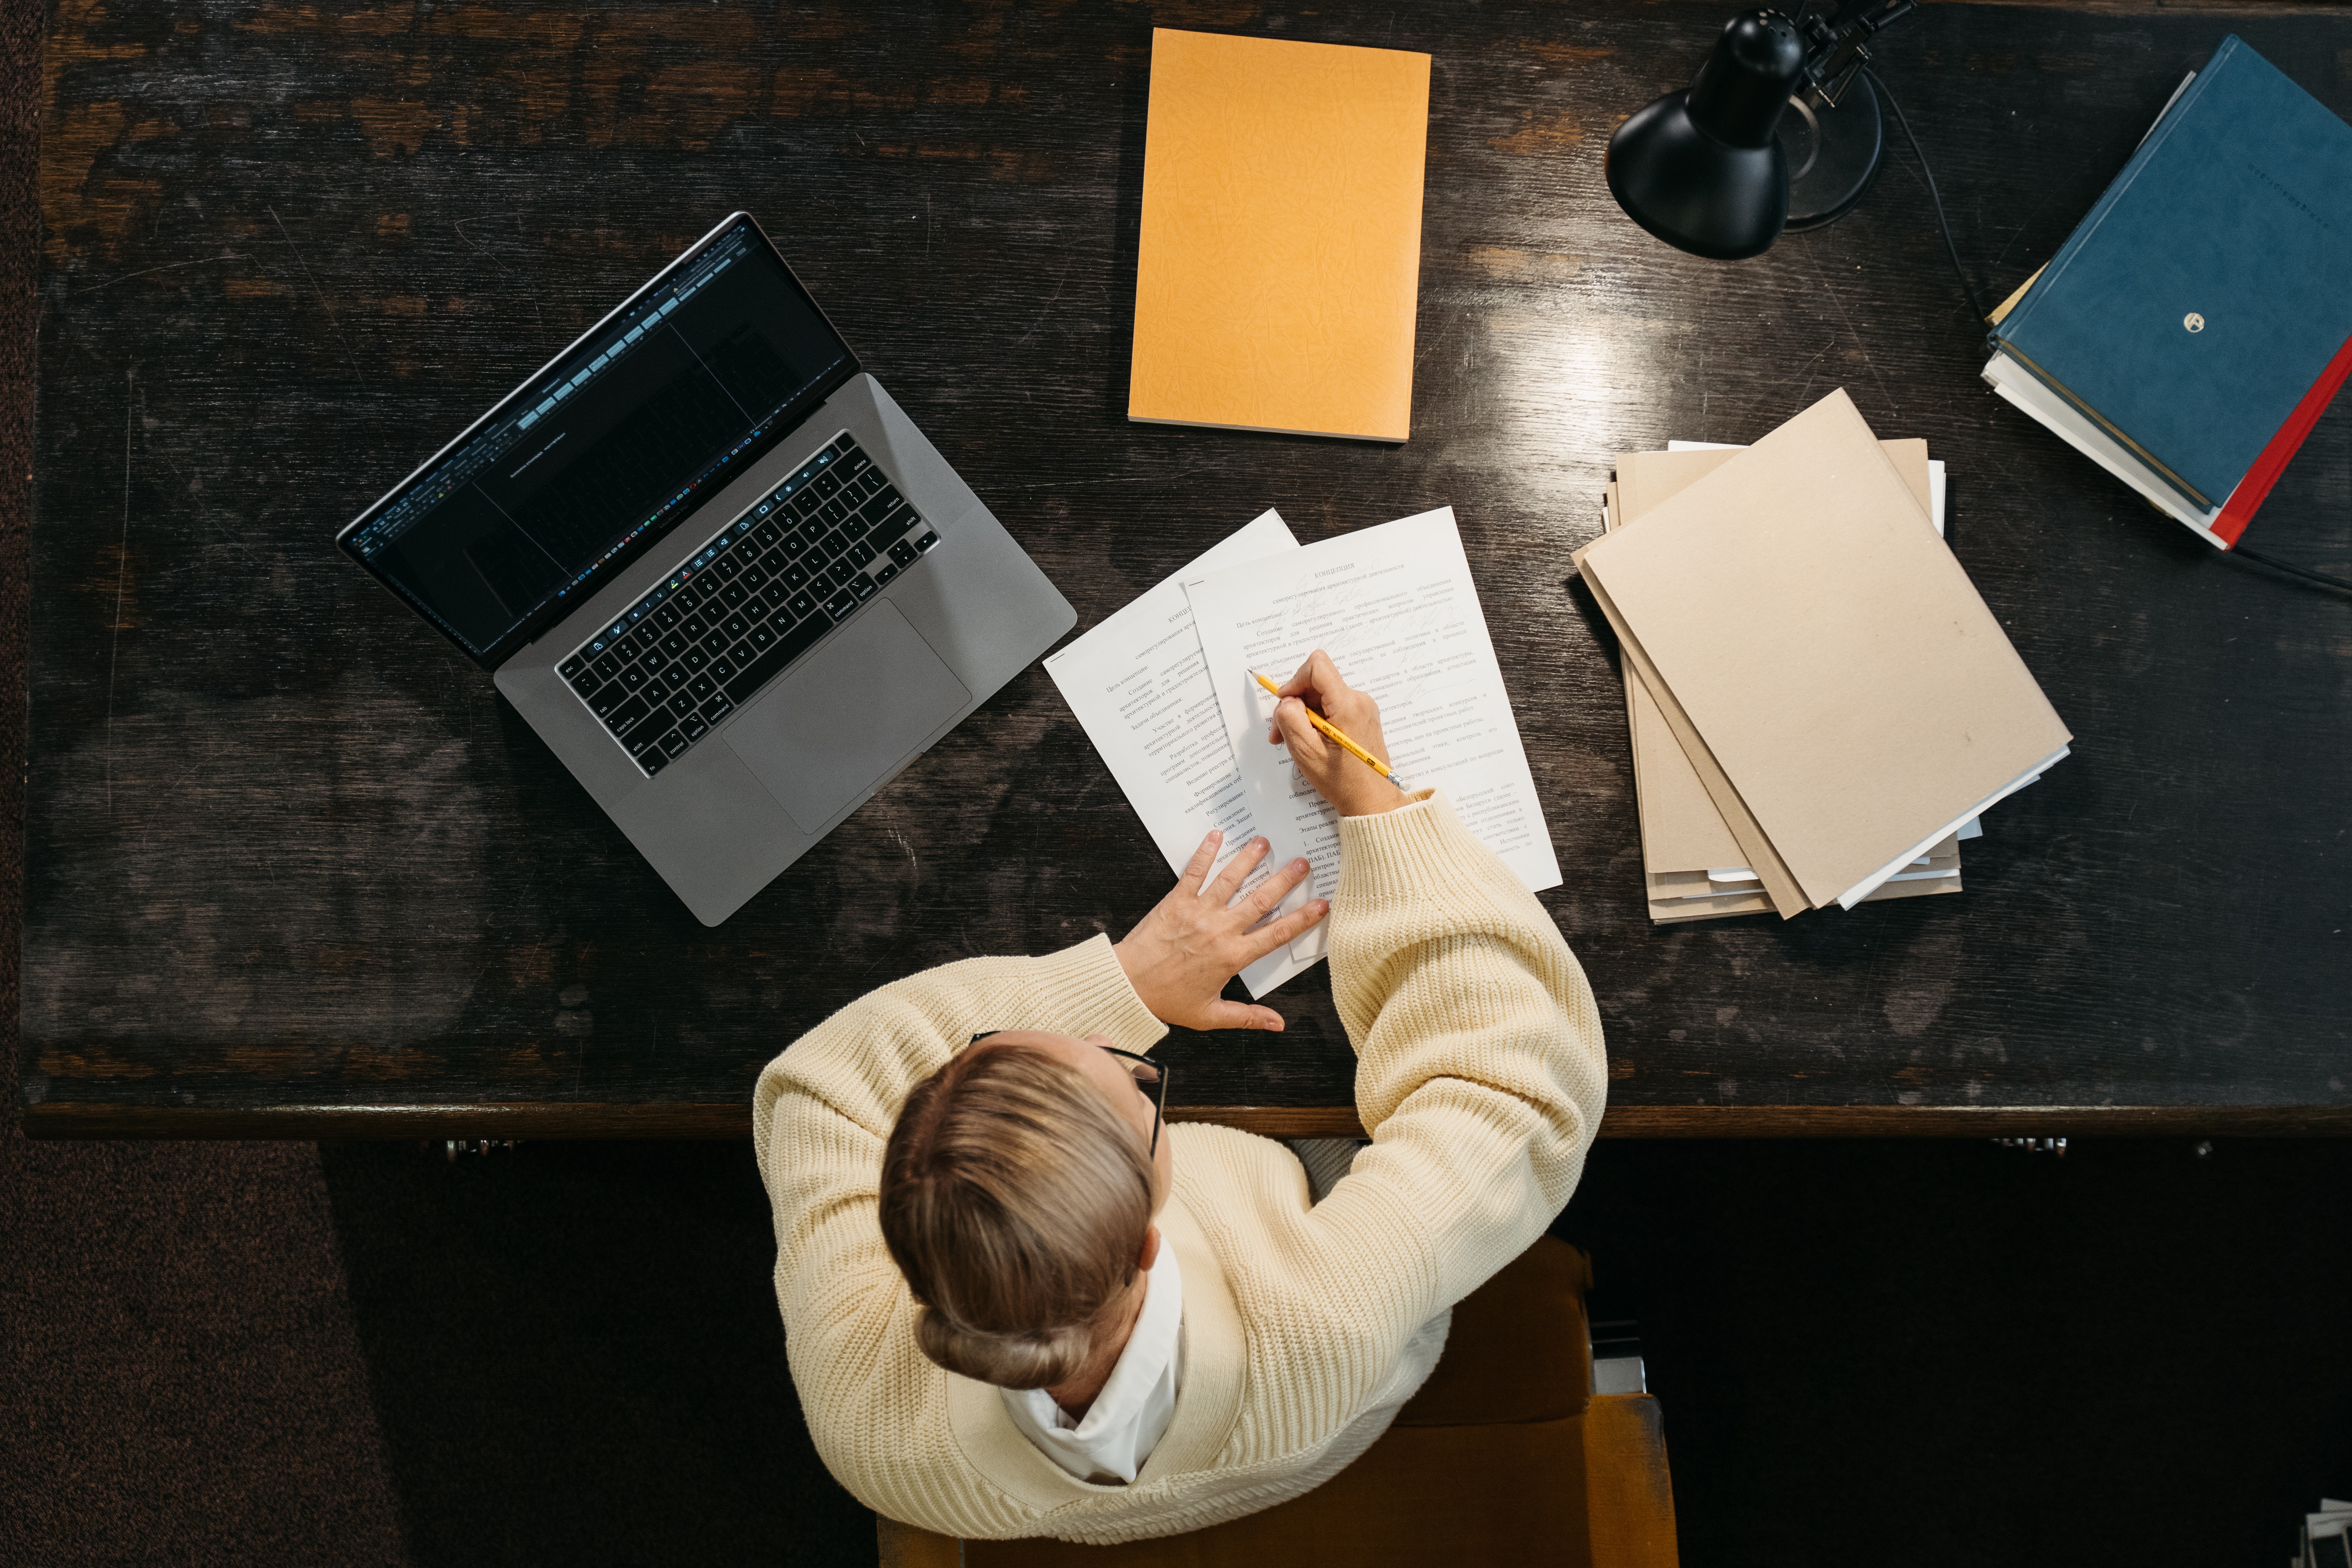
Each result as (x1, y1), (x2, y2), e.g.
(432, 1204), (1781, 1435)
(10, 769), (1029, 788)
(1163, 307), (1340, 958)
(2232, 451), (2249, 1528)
(24, 0), (2352, 1135)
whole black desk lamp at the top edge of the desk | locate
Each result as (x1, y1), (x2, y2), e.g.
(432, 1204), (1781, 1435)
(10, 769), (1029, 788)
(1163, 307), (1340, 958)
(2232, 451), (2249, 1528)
(1606, 0), (1915, 261)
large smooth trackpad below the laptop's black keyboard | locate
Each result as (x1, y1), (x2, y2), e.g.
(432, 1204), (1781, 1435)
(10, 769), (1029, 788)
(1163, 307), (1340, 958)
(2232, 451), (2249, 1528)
(727, 604), (971, 832)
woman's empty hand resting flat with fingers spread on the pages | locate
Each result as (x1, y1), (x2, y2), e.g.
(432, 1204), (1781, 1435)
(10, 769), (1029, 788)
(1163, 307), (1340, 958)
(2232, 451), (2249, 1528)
(1113, 832), (1331, 1030)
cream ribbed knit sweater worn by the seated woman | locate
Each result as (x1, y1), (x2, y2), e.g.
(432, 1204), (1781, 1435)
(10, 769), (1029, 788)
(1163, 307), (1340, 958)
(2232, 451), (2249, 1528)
(752, 792), (1606, 1542)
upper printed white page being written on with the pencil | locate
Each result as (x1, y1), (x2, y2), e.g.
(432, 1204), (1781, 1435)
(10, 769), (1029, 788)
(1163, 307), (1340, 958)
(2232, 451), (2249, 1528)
(1186, 508), (1559, 997)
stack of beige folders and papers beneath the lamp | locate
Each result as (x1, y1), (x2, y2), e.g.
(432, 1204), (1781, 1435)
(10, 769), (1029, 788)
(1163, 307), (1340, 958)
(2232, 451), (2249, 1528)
(1576, 390), (2072, 924)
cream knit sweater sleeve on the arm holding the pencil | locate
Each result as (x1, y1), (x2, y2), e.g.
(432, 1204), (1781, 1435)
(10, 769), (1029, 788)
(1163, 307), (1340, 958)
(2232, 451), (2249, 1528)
(1317, 792), (1609, 1333)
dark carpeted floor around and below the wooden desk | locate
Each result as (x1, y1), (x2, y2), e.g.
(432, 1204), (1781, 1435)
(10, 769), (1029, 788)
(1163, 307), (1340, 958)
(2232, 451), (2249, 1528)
(0, 0), (2352, 1568)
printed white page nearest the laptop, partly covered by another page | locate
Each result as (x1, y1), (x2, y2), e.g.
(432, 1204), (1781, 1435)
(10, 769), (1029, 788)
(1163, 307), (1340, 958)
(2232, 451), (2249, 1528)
(1044, 510), (1298, 875)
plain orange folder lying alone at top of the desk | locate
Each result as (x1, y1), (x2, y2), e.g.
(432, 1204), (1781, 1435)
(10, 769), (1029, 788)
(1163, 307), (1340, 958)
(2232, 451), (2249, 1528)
(1127, 28), (1430, 442)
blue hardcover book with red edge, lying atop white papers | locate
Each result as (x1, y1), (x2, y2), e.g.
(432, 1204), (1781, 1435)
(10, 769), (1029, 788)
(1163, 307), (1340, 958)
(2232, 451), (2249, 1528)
(1992, 35), (2352, 546)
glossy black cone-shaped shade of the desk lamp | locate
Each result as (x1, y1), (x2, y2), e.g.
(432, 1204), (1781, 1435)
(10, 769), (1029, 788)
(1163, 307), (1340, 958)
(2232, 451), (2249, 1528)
(1606, 12), (1804, 261)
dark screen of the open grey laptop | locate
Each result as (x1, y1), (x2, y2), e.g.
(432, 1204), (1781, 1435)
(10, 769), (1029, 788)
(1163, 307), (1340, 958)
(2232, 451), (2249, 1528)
(339, 214), (856, 665)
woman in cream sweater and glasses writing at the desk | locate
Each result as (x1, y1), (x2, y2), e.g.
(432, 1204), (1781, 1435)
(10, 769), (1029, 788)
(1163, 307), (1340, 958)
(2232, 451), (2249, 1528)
(755, 654), (1606, 1542)
